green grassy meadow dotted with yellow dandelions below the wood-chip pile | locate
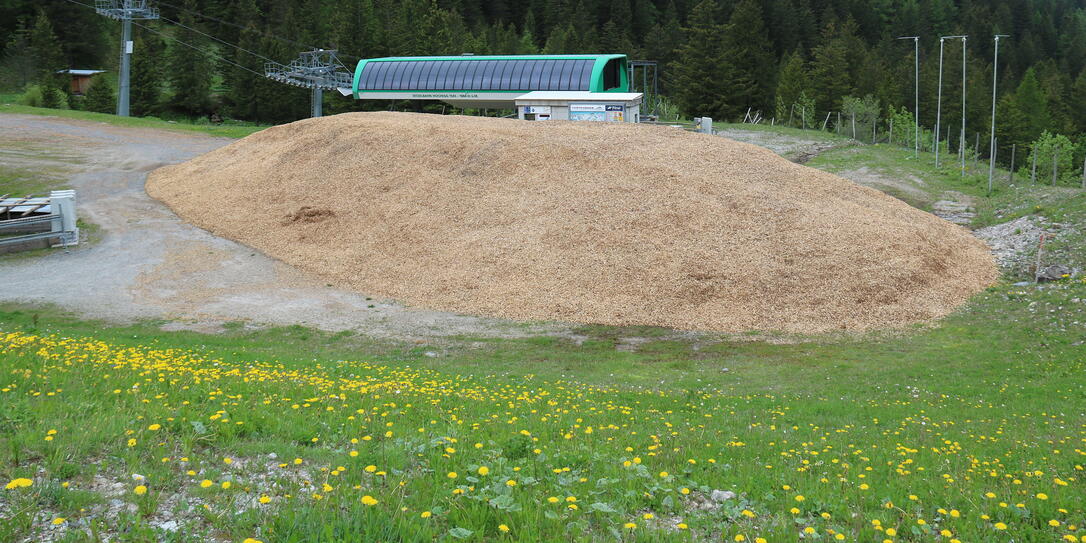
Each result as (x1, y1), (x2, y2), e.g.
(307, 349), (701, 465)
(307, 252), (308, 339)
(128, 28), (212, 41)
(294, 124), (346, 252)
(0, 123), (1086, 542)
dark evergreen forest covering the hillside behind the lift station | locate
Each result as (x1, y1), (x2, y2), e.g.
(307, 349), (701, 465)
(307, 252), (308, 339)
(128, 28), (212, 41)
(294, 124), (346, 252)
(0, 0), (1086, 165)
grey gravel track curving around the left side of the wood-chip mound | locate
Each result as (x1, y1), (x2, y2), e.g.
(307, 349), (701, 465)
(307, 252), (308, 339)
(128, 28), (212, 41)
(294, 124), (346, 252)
(0, 114), (565, 340)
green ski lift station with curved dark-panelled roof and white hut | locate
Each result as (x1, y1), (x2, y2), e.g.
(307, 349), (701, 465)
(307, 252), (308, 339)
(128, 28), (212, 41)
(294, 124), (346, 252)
(352, 54), (643, 123)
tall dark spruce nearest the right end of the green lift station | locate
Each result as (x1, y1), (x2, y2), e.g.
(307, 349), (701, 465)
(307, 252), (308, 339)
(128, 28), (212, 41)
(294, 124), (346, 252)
(670, 0), (731, 119)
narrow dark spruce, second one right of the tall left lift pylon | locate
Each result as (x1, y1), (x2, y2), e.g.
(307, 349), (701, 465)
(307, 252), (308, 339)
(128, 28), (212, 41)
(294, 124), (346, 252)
(168, 0), (213, 116)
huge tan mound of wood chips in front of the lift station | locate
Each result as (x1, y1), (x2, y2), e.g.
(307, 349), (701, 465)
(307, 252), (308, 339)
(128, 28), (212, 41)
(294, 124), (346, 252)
(147, 113), (997, 332)
